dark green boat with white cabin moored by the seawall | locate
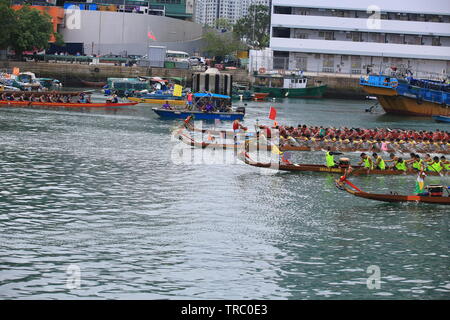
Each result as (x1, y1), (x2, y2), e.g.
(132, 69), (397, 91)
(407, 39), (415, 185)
(253, 72), (327, 98)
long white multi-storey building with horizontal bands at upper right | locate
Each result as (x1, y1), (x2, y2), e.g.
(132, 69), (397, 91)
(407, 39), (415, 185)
(270, 0), (450, 76)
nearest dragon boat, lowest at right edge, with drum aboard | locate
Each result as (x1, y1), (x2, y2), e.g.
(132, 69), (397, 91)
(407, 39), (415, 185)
(336, 180), (450, 205)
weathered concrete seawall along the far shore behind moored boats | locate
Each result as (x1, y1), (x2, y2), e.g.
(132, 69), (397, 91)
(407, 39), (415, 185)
(0, 61), (366, 99)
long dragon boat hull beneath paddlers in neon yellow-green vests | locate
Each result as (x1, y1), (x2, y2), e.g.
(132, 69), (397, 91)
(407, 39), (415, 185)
(238, 152), (449, 176)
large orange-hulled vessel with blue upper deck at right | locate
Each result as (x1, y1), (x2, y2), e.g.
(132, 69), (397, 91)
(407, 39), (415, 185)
(359, 75), (450, 117)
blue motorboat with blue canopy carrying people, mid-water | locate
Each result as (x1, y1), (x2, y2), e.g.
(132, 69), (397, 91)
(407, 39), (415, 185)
(152, 93), (245, 121)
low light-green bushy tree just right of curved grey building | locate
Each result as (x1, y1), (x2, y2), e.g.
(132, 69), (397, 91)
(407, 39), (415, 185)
(204, 31), (245, 56)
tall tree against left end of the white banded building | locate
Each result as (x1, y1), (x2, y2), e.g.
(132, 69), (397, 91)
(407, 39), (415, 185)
(233, 4), (270, 49)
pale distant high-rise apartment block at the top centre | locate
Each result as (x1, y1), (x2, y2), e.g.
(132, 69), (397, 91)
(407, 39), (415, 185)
(194, 0), (270, 26)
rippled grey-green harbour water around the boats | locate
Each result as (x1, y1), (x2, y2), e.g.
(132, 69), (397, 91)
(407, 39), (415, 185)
(0, 100), (450, 299)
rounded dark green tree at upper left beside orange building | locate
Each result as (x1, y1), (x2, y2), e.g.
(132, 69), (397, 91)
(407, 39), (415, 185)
(10, 5), (53, 55)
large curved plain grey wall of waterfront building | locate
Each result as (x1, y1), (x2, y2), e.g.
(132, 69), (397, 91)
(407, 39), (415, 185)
(60, 10), (203, 55)
